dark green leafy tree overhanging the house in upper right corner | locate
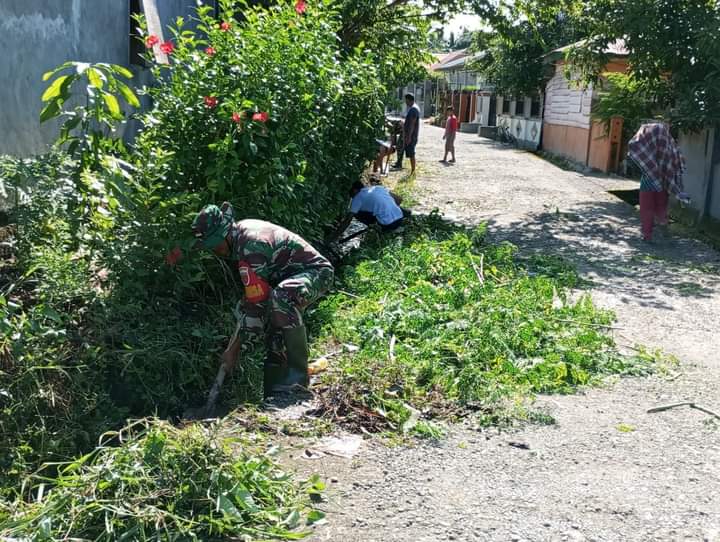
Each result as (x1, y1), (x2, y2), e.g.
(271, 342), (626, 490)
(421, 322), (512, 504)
(568, 0), (720, 130)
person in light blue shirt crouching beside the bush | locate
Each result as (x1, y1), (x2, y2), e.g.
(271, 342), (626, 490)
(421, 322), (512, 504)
(350, 181), (404, 232)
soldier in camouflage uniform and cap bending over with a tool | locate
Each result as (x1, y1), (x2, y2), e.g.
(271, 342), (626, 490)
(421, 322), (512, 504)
(193, 203), (334, 396)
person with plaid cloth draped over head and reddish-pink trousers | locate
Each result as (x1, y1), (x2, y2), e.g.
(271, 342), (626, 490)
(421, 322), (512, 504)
(628, 122), (689, 242)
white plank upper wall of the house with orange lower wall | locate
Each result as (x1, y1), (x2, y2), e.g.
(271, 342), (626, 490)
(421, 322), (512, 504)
(545, 65), (593, 128)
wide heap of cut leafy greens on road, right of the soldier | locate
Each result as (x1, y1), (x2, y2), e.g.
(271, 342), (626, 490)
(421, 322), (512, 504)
(314, 214), (652, 433)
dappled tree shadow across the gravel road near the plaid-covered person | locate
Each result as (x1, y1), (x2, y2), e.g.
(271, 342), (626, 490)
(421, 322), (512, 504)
(488, 200), (720, 310)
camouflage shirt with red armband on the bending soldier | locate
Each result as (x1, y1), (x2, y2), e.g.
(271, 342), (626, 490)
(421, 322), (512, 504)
(230, 220), (332, 303)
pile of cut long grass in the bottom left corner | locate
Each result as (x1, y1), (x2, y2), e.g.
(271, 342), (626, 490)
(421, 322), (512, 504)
(0, 420), (323, 542)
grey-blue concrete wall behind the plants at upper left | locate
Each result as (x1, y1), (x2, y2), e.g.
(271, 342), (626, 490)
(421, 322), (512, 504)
(0, 0), (195, 156)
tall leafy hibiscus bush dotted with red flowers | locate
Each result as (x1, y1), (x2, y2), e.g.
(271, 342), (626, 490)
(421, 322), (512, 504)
(137, 0), (384, 239)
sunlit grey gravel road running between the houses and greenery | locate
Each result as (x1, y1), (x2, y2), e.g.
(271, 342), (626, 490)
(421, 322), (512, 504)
(294, 126), (720, 542)
